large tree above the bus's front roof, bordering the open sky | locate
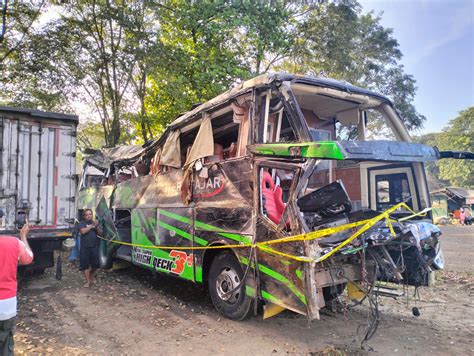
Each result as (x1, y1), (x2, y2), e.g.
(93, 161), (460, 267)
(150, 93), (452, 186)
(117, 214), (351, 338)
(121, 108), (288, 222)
(277, 0), (426, 130)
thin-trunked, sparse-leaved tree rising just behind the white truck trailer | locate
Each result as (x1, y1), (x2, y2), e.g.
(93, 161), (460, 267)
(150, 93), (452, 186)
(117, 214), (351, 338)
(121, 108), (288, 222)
(2, 0), (156, 147)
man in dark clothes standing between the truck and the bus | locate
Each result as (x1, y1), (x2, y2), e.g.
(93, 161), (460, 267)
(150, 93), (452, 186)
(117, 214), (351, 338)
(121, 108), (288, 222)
(79, 209), (101, 288)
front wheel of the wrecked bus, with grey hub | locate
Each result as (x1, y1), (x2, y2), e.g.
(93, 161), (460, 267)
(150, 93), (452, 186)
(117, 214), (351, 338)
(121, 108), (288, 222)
(209, 252), (252, 321)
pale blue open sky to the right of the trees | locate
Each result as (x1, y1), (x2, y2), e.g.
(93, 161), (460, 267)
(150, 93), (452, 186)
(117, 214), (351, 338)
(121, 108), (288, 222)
(359, 0), (474, 133)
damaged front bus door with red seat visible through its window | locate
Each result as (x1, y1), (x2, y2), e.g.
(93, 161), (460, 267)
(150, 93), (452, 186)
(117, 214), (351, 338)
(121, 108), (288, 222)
(255, 163), (307, 315)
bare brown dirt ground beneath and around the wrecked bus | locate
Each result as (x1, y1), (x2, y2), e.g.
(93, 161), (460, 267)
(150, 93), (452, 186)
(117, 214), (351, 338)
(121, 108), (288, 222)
(15, 227), (474, 355)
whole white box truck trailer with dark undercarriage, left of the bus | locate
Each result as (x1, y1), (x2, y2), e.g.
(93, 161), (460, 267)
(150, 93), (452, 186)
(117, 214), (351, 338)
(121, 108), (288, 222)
(0, 106), (78, 271)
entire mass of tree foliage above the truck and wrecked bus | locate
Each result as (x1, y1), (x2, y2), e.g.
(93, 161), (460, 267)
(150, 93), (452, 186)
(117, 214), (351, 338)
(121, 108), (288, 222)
(0, 0), (425, 146)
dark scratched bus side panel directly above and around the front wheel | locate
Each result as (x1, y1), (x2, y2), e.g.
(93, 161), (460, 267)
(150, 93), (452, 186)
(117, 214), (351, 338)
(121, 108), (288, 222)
(193, 159), (255, 289)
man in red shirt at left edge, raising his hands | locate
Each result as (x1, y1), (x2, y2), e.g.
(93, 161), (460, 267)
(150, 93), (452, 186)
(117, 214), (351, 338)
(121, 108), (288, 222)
(0, 210), (33, 356)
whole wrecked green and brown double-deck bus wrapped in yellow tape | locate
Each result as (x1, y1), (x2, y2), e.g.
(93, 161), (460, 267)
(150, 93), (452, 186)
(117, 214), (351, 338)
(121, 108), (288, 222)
(77, 73), (456, 320)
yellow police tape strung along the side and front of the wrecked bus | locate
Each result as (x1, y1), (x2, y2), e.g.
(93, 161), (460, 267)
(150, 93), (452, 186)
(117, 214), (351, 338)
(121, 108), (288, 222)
(99, 203), (431, 263)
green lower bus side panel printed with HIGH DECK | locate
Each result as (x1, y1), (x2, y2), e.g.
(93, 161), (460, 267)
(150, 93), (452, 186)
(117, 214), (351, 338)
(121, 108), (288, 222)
(131, 207), (195, 281)
